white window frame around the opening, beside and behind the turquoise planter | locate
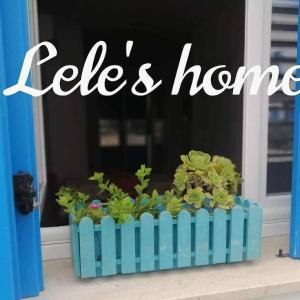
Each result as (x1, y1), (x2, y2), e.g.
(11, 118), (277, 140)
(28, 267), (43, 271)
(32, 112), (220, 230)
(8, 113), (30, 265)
(34, 0), (290, 260)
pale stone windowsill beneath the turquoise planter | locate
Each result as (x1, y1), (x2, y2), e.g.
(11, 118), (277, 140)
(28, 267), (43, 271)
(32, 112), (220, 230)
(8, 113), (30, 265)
(32, 236), (300, 300)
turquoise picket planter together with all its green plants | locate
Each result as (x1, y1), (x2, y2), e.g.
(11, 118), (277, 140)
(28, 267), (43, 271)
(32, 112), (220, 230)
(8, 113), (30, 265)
(57, 151), (262, 278)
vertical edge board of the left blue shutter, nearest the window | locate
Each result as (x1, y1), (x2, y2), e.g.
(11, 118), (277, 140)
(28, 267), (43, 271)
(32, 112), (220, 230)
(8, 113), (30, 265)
(0, 0), (43, 297)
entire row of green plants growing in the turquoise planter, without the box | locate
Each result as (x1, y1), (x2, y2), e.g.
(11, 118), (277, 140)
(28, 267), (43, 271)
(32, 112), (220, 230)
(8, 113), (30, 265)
(57, 150), (242, 223)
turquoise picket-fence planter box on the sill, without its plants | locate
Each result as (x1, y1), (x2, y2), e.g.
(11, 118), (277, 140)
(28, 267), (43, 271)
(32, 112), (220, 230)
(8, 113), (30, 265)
(70, 197), (262, 278)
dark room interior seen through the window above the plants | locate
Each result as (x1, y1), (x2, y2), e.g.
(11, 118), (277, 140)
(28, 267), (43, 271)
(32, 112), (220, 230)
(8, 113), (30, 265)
(39, 0), (245, 226)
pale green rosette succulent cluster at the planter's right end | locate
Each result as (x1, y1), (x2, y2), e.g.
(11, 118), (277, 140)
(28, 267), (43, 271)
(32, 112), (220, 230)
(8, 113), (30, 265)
(173, 150), (242, 211)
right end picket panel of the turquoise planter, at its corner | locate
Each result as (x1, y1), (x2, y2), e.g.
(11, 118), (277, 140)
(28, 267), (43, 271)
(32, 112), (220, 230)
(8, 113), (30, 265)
(245, 201), (262, 260)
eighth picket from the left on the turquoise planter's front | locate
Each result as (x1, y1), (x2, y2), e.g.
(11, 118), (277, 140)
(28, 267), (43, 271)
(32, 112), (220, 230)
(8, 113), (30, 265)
(212, 208), (227, 264)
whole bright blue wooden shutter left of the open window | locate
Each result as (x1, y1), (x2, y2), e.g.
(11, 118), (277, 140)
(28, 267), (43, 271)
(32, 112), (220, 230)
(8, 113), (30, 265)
(0, 0), (43, 300)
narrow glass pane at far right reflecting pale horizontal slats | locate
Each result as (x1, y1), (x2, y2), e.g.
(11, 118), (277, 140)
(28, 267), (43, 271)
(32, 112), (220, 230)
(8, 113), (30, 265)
(267, 0), (298, 194)
